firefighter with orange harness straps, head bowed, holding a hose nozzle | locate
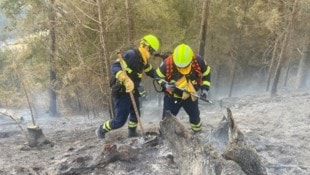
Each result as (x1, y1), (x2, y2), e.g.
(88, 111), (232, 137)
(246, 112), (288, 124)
(156, 44), (211, 132)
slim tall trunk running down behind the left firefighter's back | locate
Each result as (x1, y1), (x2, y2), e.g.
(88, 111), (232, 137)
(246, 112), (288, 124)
(97, 0), (114, 118)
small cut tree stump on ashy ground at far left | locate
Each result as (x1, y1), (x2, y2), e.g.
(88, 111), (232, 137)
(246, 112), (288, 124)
(27, 125), (50, 147)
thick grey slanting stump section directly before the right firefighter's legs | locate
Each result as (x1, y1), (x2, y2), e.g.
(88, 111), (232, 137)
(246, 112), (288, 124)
(160, 112), (245, 175)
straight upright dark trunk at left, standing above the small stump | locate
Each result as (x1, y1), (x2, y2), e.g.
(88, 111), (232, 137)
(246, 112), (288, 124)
(49, 0), (58, 116)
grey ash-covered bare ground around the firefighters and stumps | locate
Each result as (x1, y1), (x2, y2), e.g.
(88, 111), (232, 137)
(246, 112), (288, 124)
(0, 90), (310, 175)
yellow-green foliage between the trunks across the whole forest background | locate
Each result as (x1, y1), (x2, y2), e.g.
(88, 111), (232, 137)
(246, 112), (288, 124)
(0, 0), (310, 111)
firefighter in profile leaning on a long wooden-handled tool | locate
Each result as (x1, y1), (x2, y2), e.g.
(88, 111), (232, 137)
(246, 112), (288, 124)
(96, 35), (160, 139)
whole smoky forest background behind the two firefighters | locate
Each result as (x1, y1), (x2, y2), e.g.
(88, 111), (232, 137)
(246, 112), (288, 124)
(0, 0), (310, 116)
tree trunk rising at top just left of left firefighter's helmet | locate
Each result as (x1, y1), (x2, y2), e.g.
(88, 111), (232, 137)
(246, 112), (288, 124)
(125, 0), (135, 47)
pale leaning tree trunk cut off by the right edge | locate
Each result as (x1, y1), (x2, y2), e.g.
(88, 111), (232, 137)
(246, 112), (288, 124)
(296, 37), (310, 89)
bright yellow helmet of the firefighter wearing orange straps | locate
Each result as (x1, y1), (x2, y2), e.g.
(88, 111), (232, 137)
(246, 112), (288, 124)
(172, 44), (194, 74)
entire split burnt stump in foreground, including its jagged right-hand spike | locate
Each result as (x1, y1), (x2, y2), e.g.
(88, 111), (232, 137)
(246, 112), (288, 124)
(160, 109), (266, 175)
